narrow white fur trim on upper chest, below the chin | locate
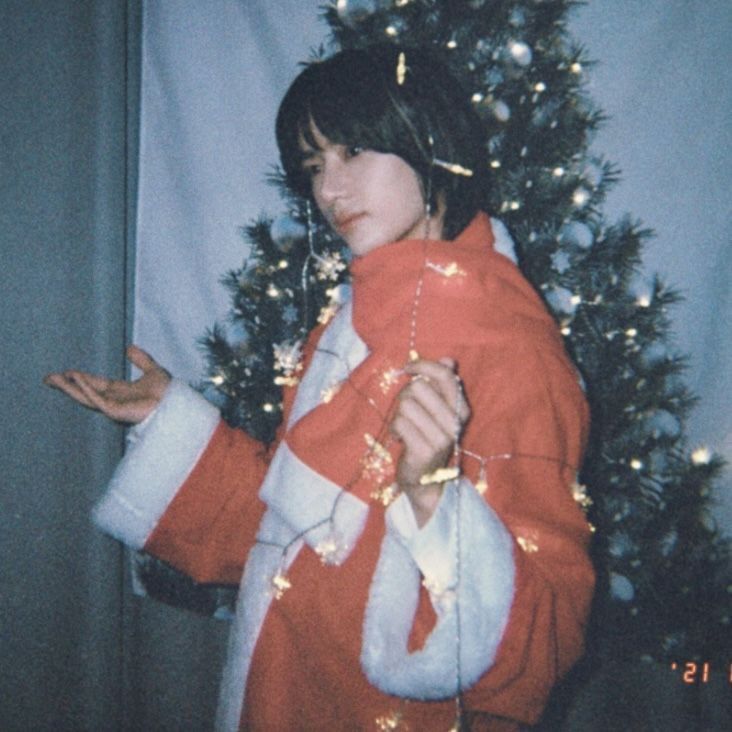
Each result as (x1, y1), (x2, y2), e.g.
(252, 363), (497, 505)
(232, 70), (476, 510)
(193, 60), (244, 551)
(287, 300), (369, 428)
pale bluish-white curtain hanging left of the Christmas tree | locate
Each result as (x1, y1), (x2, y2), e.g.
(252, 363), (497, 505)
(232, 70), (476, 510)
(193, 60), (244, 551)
(134, 0), (324, 379)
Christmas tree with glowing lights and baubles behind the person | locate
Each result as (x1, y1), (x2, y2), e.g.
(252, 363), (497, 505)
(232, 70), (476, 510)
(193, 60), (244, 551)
(141, 0), (732, 676)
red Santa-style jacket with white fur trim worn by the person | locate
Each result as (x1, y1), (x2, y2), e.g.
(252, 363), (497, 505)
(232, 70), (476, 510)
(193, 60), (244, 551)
(97, 210), (594, 730)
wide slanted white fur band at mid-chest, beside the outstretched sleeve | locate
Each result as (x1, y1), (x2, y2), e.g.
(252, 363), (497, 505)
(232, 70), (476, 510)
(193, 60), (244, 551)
(259, 440), (369, 564)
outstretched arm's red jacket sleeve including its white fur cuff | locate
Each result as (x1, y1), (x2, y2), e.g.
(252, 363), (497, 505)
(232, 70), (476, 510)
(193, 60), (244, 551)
(93, 380), (268, 584)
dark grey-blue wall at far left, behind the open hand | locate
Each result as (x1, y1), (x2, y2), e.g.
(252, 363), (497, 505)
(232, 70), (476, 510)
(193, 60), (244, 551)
(0, 0), (126, 730)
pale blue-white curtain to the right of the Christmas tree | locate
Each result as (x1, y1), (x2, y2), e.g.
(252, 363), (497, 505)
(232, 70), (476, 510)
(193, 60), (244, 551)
(572, 0), (732, 535)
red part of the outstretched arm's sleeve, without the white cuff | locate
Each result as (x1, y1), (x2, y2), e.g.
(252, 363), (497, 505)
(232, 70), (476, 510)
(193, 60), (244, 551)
(144, 422), (269, 584)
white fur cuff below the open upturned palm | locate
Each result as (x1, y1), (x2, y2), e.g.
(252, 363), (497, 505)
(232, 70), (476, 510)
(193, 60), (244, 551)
(92, 379), (221, 549)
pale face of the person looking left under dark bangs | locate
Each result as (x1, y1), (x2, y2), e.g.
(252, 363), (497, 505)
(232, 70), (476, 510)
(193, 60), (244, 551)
(301, 126), (443, 257)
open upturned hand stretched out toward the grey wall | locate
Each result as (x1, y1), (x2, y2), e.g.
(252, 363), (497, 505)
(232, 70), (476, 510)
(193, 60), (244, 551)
(43, 346), (170, 424)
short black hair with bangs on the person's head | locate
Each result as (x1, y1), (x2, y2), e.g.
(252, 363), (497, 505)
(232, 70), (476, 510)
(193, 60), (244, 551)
(276, 44), (487, 239)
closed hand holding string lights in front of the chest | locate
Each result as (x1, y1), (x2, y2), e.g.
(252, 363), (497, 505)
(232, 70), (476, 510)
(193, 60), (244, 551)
(390, 358), (470, 527)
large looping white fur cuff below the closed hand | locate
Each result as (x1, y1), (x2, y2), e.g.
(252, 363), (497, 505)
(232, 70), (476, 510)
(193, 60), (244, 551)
(361, 479), (515, 699)
